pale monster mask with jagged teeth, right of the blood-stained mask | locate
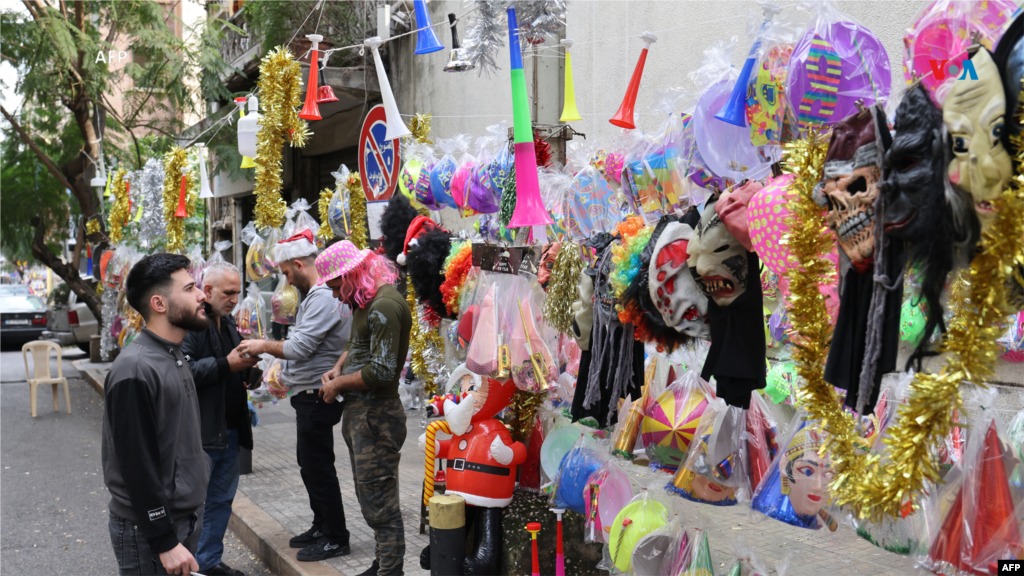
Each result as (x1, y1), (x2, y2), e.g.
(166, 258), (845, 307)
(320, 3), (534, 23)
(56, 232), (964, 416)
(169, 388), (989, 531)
(687, 202), (748, 306)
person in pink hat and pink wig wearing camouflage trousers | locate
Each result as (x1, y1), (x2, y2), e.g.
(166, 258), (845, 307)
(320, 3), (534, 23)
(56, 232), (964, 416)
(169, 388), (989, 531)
(316, 240), (413, 576)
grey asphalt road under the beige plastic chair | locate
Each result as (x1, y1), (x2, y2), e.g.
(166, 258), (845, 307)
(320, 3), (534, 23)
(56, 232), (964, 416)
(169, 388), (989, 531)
(0, 344), (270, 576)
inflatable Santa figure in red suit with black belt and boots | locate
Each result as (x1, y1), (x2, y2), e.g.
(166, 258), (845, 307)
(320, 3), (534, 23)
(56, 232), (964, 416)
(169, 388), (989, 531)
(420, 365), (526, 576)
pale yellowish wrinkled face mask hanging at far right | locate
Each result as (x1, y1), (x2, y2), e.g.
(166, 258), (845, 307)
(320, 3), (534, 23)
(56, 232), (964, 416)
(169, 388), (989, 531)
(942, 48), (1013, 230)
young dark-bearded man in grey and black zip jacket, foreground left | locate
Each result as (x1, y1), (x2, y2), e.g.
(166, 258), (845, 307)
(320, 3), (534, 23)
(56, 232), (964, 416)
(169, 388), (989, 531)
(101, 254), (210, 576)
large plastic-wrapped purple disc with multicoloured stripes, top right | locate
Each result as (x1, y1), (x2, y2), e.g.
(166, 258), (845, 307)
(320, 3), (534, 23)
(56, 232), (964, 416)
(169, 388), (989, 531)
(785, 0), (892, 131)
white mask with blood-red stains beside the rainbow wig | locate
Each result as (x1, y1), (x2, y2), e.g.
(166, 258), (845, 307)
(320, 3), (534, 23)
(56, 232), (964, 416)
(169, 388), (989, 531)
(648, 218), (711, 339)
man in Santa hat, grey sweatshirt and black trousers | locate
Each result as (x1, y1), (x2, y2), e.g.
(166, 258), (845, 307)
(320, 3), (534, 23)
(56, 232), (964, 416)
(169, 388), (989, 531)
(238, 230), (351, 562)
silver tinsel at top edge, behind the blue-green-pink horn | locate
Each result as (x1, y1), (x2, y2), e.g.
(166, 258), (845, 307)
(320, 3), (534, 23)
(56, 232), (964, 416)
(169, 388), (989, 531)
(462, 0), (567, 75)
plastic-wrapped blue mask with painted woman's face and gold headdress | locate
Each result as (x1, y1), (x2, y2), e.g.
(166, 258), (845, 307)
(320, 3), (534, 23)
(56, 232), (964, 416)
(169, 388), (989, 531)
(751, 410), (839, 531)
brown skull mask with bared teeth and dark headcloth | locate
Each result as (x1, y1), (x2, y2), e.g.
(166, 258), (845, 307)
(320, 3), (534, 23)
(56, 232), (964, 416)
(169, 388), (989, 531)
(814, 113), (881, 272)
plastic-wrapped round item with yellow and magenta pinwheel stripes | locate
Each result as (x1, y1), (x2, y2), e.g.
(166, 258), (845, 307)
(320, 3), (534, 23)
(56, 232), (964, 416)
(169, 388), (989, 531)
(640, 370), (715, 468)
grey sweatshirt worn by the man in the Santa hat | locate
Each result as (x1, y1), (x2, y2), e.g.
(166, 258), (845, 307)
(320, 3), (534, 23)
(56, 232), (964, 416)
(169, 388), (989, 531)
(282, 286), (352, 393)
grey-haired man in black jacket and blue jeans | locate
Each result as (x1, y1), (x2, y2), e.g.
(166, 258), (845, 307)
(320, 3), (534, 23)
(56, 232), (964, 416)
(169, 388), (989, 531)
(181, 262), (259, 576)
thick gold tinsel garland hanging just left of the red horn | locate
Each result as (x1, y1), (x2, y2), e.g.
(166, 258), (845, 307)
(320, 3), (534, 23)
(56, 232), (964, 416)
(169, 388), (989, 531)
(253, 46), (309, 230)
